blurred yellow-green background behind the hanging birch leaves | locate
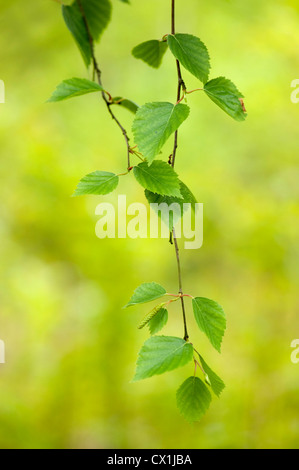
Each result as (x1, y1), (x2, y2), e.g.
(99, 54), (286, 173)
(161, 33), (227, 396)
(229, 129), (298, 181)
(0, 0), (299, 448)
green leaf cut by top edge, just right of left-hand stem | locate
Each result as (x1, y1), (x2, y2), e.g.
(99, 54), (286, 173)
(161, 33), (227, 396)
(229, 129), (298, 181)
(81, 0), (112, 41)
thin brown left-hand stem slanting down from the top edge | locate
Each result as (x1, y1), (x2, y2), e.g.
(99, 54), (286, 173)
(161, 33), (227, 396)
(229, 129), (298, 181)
(77, 0), (131, 170)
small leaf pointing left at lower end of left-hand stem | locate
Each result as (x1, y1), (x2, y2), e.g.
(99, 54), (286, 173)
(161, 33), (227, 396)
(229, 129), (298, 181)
(73, 171), (119, 196)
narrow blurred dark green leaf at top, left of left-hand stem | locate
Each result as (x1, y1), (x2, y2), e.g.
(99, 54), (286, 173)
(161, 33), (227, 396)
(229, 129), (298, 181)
(62, 3), (92, 67)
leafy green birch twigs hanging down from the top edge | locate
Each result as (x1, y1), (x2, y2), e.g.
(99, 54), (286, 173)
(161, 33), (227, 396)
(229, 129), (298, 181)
(49, 0), (246, 421)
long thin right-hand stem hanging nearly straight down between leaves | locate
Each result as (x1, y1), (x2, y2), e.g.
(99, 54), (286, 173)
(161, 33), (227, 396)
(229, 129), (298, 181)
(171, 0), (189, 341)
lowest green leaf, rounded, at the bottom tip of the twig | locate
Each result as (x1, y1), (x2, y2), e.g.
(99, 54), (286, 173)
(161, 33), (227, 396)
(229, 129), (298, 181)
(176, 377), (212, 423)
